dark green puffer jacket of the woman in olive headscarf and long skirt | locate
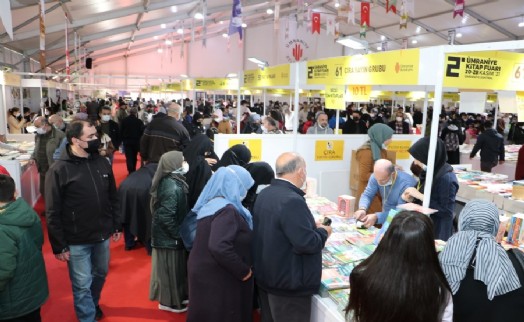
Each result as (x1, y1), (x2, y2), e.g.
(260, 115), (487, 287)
(151, 175), (187, 249)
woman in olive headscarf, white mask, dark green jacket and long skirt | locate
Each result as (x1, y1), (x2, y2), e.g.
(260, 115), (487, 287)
(149, 151), (188, 313)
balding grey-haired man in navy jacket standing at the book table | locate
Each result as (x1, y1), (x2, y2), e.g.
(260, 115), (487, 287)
(253, 153), (331, 322)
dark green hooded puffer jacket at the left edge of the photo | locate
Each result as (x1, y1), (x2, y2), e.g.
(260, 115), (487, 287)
(0, 198), (49, 320)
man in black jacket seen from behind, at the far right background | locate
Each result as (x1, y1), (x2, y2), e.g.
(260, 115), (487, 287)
(469, 121), (505, 172)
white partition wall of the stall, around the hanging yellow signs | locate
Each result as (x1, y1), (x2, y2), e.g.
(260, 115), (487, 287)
(215, 134), (421, 200)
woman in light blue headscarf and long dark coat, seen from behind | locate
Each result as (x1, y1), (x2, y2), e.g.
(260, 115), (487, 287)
(187, 165), (254, 322)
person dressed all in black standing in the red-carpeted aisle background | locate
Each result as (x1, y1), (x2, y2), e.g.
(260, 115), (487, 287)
(120, 107), (144, 174)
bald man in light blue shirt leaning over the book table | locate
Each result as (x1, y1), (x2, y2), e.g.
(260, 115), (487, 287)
(353, 159), (417, 228)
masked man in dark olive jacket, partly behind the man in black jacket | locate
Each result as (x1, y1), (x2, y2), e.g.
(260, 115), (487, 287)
(29, 116), (65, 201)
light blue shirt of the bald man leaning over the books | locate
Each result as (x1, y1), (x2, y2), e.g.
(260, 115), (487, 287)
(358, 170), (417, 224)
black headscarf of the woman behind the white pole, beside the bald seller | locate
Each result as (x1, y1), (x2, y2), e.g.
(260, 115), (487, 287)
(408, 137), (453, 193)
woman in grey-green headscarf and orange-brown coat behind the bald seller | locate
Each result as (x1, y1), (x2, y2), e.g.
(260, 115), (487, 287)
(355, 123), (393, 213)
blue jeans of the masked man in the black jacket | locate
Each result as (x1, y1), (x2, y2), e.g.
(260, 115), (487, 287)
(67, 239), (109, 322)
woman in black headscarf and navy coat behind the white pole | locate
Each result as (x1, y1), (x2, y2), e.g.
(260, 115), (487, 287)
(402, 137), (458, 241)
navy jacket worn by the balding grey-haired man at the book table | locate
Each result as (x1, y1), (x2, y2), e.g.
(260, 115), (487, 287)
(253, 179), (327, 296)
